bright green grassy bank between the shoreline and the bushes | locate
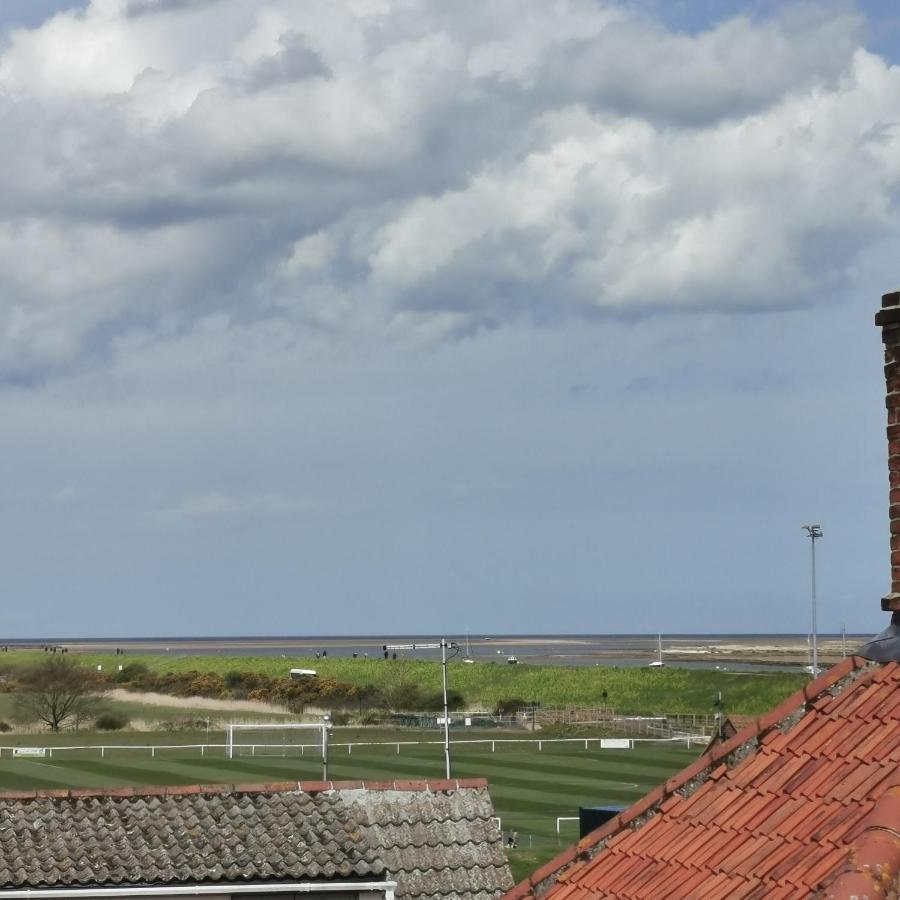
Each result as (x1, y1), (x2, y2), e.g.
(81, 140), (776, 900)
(2, 651), (809, 715)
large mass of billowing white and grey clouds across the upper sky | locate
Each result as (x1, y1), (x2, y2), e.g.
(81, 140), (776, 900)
(0, 0), (900, 375)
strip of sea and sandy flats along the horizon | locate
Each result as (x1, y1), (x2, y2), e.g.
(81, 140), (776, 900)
(5, 634), (869, 672)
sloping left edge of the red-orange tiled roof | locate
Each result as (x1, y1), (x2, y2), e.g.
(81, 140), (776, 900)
(503, 656), (868, 900)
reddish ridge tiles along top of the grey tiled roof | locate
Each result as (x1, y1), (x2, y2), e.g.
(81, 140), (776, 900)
(0, 778), (488, 801)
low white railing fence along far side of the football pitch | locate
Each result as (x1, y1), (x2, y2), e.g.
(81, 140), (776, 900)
(0, 735), (709, 759)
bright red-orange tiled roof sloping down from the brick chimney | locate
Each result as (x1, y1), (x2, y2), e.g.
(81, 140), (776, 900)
(506, 657), (900, 900)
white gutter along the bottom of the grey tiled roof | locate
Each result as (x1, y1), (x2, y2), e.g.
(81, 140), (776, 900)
(0, 881), (397, 900)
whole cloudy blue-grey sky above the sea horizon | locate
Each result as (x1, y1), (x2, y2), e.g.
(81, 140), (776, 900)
(0, 0), (900, 638)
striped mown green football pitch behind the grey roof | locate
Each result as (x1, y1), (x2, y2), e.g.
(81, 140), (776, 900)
(0, 731), (700, 879)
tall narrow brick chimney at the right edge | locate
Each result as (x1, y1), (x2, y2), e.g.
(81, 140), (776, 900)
(859, 291), (900, 662)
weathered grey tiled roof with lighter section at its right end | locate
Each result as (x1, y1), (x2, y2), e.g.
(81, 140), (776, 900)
(0, 780), (512, 898)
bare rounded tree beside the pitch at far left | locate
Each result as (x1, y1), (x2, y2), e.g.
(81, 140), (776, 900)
(15, 656), (106, 731)
